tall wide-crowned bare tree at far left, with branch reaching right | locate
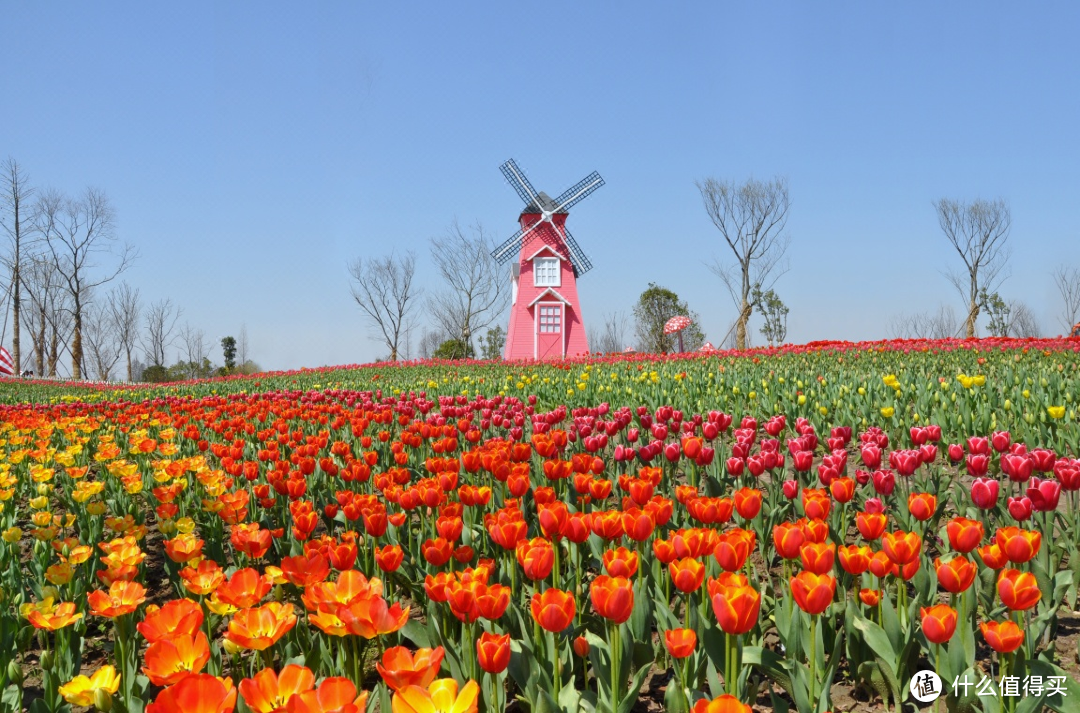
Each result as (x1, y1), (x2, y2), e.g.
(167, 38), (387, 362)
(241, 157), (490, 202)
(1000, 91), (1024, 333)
(37, 188), (136, 379)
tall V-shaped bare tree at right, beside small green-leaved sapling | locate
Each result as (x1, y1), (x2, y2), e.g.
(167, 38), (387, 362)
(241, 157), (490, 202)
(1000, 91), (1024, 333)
(934, 198), (1012, 339)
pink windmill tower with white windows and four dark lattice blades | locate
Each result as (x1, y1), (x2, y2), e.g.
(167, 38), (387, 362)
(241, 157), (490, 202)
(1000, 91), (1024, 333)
(491, 159), (604, 359)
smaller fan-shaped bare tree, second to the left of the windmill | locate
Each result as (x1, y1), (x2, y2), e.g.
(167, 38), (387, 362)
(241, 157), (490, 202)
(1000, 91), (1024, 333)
(349, 251), (421, 362)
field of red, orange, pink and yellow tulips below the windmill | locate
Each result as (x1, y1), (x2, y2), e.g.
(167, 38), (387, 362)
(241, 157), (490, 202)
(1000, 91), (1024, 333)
(6, 338), (1080, 713)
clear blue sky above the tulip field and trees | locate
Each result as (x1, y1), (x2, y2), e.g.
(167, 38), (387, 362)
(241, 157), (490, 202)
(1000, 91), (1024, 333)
(0, 2), (1080, 368)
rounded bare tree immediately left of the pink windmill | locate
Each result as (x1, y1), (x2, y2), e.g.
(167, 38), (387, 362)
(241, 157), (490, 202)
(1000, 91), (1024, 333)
(428, 220), (510, 351)
